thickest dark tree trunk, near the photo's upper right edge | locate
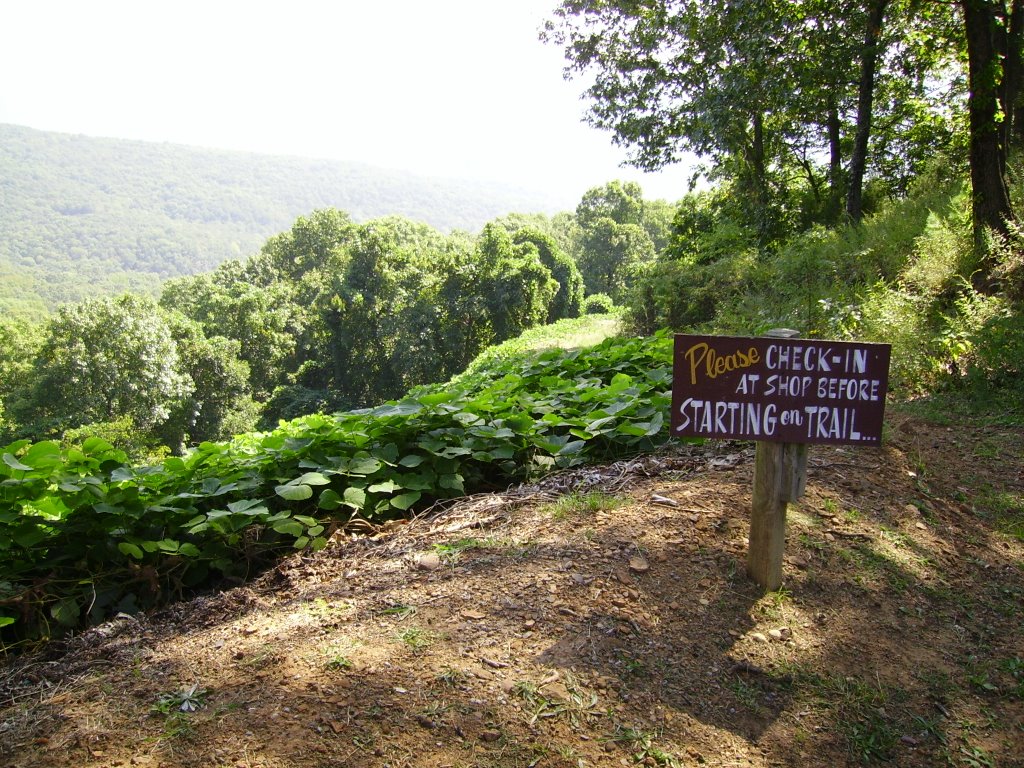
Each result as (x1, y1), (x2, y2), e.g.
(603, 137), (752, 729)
(961, 0), (1013, 259)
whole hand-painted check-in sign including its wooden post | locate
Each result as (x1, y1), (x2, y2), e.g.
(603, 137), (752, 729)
(672, 330), (891, 590)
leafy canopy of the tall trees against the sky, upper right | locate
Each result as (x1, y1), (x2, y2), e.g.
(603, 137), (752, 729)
(542, 0), (957, 234)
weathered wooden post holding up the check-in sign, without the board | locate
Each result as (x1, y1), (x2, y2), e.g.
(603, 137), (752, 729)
(746, 329), (807, 592)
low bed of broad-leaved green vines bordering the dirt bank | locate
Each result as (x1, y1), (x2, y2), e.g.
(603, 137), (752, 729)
(0, 334), (672, 647)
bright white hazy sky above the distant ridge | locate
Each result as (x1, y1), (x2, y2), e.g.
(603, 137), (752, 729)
(0, 0), (690, 207)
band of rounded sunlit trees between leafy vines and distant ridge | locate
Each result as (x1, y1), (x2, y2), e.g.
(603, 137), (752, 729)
(0, 182), (672, 458)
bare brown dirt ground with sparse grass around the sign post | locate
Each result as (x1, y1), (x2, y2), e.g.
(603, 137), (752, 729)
(0, 415), (1024, 768)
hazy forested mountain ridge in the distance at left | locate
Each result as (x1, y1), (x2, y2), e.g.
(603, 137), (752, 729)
(0, 124), (558, 316)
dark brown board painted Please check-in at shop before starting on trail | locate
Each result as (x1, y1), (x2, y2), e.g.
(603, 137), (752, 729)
(672, 334), (891, 445)
